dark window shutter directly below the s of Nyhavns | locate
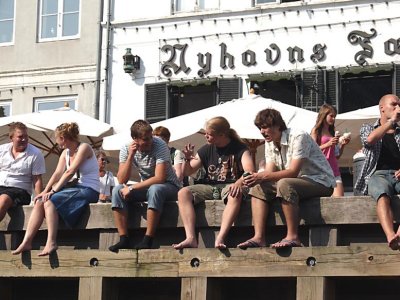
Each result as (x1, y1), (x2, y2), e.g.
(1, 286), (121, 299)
(301, 70), (325, 111)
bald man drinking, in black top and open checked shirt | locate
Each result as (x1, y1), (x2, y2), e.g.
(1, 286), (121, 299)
(354, 94), (400, 250)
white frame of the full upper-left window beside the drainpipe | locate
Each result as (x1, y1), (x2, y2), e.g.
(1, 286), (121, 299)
(38, 0), (80, 42)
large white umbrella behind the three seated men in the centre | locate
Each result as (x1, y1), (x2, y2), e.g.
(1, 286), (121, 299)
(103, 95), (317, 165)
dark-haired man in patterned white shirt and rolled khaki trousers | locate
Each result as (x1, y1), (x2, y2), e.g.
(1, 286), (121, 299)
(238, 108), (336, 249)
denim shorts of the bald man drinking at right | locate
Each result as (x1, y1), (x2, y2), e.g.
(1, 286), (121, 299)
(368, 170), (400, 201)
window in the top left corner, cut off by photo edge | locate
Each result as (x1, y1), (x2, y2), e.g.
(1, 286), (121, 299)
(0, 0), (15, 45)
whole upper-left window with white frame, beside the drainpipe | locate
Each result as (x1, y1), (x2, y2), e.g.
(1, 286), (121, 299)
(39, 0), (80, 40)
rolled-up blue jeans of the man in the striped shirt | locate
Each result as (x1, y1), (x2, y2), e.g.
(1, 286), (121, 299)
(111, 182), (179, 213)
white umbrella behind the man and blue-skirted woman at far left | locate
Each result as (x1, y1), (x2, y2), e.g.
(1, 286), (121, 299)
(0, 107), (112, 156)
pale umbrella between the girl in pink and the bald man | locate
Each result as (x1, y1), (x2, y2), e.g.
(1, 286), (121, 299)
(335, 105), (380, 167)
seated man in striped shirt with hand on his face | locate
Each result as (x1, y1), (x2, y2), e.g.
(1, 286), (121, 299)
(109, 120), (181, 252)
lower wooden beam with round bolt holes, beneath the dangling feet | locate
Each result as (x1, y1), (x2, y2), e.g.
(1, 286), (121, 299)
(0, 244), (400, 278)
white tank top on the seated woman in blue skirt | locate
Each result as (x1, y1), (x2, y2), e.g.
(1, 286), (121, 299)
(65, 145), (100, 192)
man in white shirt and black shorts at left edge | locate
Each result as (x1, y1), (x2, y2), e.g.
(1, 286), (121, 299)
(0, 122), (46, 221)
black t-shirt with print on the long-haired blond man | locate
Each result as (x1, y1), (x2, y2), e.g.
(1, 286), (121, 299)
(197, 140), (247, 184)
